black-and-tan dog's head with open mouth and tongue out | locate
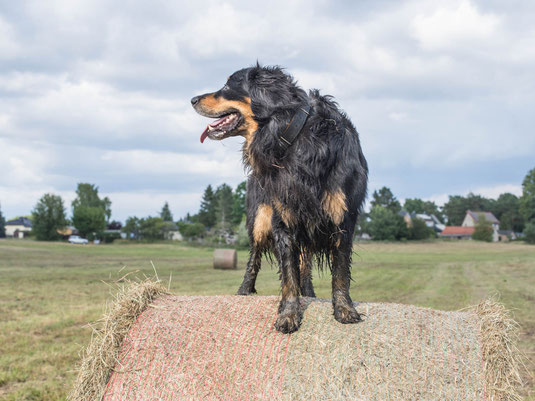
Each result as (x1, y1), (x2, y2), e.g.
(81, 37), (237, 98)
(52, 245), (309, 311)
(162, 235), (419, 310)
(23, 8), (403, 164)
(191, 65), (306, 142)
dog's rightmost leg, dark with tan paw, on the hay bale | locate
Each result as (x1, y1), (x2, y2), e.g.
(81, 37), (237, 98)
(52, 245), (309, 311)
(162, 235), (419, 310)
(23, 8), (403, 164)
(332, 242), (362, 323)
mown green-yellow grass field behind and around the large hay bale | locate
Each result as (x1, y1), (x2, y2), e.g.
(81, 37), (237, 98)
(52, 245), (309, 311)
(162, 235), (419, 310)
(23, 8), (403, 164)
(0, 240), (535, 401)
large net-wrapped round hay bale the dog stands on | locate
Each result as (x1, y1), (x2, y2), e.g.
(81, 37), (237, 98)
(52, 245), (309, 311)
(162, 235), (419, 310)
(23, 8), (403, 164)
(70, 282), (520, 401)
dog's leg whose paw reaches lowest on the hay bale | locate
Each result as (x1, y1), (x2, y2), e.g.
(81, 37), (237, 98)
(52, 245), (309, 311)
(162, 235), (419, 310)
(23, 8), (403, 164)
(273, 223), (302, 333)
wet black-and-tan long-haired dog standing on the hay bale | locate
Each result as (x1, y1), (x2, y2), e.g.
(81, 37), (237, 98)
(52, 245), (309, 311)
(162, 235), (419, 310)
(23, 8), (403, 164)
(191, 63), (368, 333)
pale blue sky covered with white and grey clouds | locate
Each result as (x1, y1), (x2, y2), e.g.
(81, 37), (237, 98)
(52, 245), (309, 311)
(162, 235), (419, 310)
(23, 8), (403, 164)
(0, 0), (535, 221)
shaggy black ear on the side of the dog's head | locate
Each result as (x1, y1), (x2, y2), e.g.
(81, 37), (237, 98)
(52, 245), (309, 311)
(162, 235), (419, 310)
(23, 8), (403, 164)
(247, 66), (297, 118)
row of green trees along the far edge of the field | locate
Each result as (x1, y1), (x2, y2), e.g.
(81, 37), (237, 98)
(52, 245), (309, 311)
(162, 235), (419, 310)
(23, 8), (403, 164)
(0, 168), (535, 245)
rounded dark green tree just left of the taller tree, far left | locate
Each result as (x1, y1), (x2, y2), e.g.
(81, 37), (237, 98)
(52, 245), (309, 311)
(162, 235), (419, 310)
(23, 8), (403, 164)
(32, 194), (67, 241)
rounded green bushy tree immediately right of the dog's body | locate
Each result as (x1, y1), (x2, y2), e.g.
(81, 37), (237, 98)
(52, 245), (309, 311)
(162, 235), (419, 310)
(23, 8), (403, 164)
(366, 206), (408, 241)
